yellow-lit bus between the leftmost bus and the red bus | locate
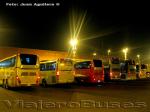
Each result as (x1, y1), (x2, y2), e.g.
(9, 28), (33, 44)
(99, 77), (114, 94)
(40, 58), (74, 86)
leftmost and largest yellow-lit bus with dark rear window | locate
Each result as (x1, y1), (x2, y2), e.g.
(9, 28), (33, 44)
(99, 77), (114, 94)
(0, 54), (40, 88)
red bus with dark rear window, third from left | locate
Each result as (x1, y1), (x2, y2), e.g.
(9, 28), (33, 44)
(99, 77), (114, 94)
(74, 59), (104, 83)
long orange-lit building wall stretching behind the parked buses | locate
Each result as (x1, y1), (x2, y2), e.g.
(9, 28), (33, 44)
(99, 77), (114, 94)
(0, 47), (129, 61)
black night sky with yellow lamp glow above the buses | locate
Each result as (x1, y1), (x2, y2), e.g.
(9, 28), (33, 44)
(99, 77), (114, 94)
(0, 0), (150, 62)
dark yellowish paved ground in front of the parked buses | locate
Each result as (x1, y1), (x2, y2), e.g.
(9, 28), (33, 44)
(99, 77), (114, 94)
(0, 80), (150, 112)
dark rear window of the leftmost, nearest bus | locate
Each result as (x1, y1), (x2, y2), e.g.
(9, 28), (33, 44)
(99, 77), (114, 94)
(20, 54), (37, 65)
